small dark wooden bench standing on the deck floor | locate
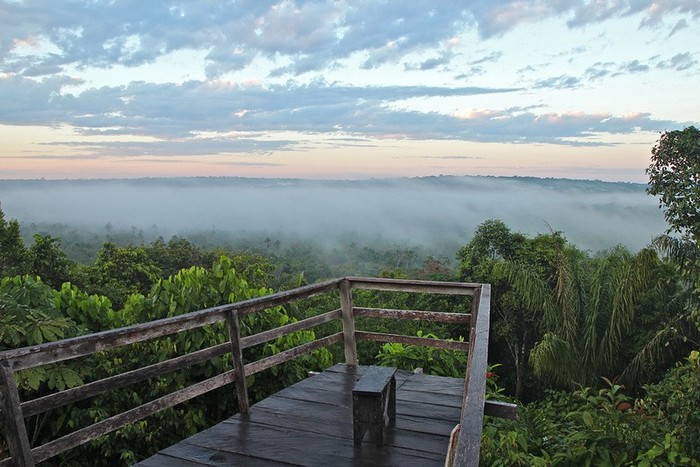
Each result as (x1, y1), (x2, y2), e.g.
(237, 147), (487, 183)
(352, 366), (396, 446)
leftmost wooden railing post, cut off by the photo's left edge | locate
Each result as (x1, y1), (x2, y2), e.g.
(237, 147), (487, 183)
(0, 360), (34, 467)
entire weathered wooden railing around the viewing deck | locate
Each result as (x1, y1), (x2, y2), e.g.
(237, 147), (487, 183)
(0, 277), (490, 467)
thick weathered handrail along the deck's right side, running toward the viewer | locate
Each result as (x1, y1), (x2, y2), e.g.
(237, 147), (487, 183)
(454, 284), (491, 467)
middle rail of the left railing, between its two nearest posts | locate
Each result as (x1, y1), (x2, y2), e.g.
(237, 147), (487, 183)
(22, 343), (231, 417)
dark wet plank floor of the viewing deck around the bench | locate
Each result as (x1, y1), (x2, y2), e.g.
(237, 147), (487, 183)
(138, 364), (463, 467)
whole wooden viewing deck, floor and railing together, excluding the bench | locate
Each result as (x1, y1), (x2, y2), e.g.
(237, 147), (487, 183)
(0, 277), (492, 467)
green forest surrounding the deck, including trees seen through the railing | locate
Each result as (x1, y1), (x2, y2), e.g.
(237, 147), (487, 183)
(0, 127), (700, 466)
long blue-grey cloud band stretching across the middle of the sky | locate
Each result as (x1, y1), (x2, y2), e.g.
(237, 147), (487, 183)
(0, 70), (678, 155)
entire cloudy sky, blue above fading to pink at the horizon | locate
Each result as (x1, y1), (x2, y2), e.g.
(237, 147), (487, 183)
(0, 0), (700, 182)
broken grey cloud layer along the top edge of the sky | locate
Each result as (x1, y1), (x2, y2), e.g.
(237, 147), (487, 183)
(0, 0), (700, 78)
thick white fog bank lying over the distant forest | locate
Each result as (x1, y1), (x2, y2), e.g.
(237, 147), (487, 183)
(0, 176), (667, 257)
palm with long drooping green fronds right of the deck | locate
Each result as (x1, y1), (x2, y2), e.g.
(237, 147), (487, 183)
(499, 247), (658, 386)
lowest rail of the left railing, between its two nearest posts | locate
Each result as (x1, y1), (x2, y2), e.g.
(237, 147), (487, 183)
(32, 370), (235, 462)
